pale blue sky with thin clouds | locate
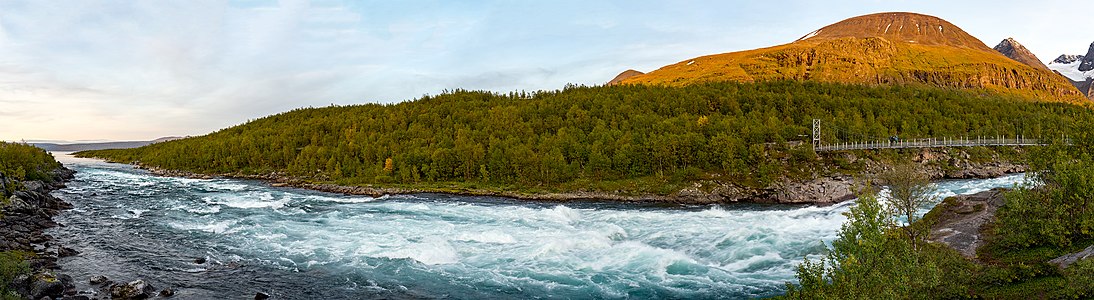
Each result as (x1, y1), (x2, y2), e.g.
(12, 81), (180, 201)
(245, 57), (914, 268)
(0, 0), (1094, 141)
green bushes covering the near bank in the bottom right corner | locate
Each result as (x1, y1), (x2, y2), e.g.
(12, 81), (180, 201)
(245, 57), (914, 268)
(785, 131), (1094, 299)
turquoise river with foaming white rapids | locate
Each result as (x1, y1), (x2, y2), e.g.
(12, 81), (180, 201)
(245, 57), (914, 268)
(51, 155), (1023, 299)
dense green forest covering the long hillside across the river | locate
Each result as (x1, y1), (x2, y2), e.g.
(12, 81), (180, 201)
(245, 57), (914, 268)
(79, 81), (1092, 193)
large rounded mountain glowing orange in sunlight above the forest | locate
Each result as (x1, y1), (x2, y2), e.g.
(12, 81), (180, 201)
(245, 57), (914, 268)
(622, 12), (1086, 103)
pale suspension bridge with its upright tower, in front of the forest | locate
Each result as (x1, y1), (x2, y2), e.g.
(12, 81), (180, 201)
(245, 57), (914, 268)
(813, 119), (1047, 152)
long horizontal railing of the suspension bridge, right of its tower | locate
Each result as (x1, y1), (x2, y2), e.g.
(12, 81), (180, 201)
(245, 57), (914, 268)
(814, 137), (1045, 152)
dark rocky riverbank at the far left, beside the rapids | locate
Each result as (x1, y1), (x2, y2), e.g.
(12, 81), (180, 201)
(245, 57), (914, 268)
(0, 168), (79, 299)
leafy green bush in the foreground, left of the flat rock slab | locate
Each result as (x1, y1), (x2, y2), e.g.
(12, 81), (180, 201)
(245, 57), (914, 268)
(785, 195), (975, 299)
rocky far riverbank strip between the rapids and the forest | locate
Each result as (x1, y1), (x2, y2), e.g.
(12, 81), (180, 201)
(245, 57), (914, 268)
(117, 148), (1026, 205)
